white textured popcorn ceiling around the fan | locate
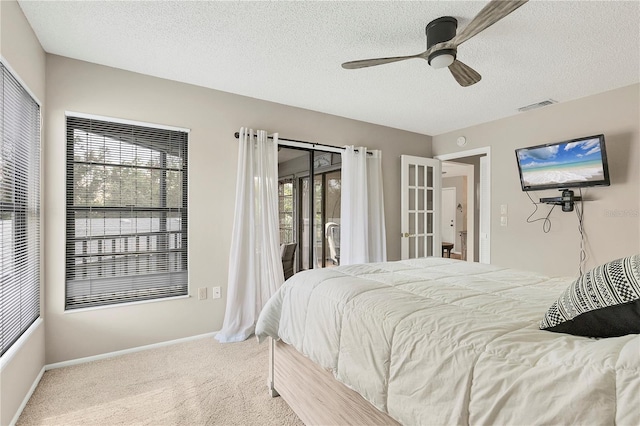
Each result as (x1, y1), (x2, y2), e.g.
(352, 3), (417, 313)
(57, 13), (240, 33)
(19, 1), (640, 135)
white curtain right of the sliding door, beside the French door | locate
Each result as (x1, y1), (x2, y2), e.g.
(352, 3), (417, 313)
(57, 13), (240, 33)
(340, 146), (387, 265)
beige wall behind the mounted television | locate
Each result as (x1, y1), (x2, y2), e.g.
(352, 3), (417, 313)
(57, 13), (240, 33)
(432, 85), (640, 276)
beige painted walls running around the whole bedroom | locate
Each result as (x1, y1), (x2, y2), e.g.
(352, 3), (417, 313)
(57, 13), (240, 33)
(8, 1), (640, 412)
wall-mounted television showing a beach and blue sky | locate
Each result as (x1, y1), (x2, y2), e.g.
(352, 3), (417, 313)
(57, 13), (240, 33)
(516, 135), (609, 191)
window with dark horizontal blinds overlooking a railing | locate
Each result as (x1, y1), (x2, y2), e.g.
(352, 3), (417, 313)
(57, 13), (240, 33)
(65, 116), (188, 309)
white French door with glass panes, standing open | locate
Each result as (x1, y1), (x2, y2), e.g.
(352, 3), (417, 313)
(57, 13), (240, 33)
(400, 155), (442, 259)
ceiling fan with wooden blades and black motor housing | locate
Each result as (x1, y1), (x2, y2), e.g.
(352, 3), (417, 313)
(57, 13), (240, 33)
(342, 0), (528, 87)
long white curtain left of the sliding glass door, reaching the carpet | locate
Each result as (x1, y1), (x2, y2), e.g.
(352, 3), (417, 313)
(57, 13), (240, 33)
(216, 127), (284, 342)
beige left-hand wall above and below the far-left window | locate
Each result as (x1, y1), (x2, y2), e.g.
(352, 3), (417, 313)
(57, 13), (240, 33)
(0, 1), (46, 425)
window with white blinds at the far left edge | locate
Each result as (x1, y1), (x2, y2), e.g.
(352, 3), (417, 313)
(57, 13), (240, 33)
(0, 63), (40, 355)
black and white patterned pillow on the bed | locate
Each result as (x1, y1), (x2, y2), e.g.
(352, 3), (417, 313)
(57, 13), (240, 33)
(540, 254), (640, 337)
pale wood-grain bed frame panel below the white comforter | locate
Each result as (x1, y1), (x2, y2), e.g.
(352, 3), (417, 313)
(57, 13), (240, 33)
(268, 338), (399, 425)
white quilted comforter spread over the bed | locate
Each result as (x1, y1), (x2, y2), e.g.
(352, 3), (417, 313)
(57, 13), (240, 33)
(256, 258), (640, 425)
